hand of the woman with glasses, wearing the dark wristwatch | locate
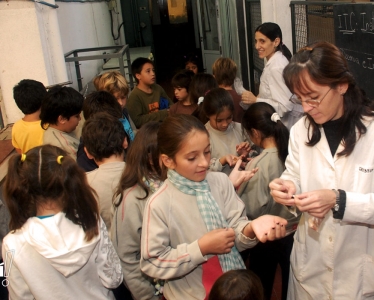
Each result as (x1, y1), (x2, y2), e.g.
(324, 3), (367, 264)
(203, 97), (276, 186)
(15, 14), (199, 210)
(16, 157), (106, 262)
(294, 189), (336, 218)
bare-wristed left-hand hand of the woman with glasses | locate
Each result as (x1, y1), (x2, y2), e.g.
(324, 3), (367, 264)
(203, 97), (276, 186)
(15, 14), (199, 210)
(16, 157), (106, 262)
(269, 178), (296, 206)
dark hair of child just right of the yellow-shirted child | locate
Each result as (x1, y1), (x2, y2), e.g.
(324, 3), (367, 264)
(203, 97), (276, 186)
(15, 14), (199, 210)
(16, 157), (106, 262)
(40, 86), (83, 128)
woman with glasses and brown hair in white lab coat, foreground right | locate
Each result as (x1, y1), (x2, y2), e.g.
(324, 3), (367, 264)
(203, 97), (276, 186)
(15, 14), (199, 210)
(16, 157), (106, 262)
(270, 42), (374, 300)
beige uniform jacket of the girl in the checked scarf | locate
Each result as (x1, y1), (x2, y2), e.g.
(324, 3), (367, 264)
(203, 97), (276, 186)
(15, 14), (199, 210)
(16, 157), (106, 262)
(140, 172), (258, 300)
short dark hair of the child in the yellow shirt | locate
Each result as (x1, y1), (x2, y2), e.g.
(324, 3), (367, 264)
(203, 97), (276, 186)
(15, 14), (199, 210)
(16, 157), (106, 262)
(13, 79), (47, 115)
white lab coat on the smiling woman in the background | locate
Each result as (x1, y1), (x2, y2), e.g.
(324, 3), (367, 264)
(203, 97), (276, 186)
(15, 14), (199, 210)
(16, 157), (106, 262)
(256, 51), (304, 130)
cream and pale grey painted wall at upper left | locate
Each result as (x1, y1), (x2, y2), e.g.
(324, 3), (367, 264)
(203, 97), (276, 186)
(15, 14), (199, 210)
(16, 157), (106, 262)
(0, 0), (125, 125)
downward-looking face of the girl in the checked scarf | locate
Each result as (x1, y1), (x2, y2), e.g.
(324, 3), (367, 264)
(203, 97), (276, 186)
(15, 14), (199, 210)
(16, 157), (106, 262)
(165, 130), (210, 182)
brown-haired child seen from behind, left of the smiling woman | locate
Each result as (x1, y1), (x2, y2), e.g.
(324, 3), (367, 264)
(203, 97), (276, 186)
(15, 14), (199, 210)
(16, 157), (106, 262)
(212, 57), (244, 123)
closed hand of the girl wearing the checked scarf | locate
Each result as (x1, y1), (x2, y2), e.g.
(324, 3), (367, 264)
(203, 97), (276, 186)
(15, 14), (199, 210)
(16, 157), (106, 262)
(198, 228), (235, 255)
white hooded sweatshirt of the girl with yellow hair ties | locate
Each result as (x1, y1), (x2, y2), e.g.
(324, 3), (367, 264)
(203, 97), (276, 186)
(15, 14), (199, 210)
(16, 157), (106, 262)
(2, 212), (123, 300)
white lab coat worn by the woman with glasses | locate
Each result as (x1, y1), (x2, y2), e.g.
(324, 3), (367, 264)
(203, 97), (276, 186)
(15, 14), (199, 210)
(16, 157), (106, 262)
(281, 117), (374, 300)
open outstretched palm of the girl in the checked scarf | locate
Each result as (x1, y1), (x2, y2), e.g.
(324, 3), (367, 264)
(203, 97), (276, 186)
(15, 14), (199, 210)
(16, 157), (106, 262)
(243, 215), (287, 243)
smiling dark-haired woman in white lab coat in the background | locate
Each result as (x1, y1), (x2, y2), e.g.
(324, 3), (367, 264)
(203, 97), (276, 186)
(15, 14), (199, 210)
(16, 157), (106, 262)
(242, 22), (303, 130)
